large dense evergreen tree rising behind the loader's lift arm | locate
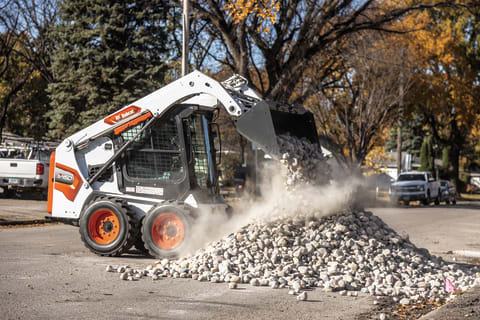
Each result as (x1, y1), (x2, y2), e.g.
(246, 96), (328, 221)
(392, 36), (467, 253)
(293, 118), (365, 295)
(47, 0), (167, 139)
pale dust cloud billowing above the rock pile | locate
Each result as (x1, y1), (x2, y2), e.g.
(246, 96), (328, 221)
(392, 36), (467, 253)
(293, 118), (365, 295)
(180, 163), (359, 256)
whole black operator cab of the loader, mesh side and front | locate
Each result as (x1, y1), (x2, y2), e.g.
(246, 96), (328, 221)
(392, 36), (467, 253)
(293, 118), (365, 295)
(113, 104), (223, 203)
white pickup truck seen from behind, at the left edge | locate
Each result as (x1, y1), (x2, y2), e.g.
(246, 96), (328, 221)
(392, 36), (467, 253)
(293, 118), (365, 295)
(0, 144), (54, 196)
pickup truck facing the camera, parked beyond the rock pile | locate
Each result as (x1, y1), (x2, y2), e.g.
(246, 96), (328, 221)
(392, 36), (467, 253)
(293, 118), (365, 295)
(389, 171), (441, 205)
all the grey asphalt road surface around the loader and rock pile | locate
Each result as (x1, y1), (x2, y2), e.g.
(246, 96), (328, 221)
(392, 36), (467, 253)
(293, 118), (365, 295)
(0, 199), (480, 320)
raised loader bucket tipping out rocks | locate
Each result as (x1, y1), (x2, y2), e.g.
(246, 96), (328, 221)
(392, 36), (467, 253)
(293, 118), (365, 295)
(237, 101), (318, 159)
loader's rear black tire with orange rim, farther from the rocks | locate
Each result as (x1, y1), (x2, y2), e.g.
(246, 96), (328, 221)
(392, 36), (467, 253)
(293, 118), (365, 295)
(79, 198), (135, 256)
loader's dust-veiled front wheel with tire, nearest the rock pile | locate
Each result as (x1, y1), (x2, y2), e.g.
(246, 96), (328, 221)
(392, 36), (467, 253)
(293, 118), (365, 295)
(142, 204), (191, 258)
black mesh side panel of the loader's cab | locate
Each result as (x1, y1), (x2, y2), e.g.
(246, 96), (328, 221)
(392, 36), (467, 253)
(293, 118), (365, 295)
(117, 115), (190, 200)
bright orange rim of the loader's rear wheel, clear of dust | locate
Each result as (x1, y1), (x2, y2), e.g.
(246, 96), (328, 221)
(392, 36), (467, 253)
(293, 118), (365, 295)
(88, 209), (120, 244)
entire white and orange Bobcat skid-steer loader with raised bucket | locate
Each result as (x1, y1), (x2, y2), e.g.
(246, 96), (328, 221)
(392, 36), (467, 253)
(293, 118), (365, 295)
(47, 71), (318, 257)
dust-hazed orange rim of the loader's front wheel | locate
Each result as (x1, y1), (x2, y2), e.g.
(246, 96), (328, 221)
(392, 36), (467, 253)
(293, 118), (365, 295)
(152, 213), (185, 250)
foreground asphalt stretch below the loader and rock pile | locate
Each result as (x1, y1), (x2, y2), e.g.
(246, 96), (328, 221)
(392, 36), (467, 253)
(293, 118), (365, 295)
(0, 225), (373, 320)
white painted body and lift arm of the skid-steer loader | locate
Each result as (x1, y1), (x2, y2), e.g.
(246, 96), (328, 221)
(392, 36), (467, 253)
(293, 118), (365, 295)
(49, 71), (251, 219)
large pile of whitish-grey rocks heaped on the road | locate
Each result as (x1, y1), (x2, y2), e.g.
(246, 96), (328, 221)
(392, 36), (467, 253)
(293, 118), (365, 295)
(107, 211), (480, 300)
